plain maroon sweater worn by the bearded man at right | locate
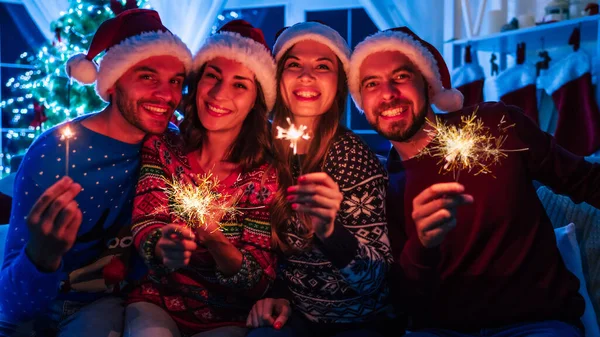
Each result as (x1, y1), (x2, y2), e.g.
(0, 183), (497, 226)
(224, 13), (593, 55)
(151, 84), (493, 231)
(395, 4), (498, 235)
(387, 103), (600, 332)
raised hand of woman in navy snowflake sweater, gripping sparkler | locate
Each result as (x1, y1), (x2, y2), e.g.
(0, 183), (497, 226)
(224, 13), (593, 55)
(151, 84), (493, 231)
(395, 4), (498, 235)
(287, 172), (344, 239)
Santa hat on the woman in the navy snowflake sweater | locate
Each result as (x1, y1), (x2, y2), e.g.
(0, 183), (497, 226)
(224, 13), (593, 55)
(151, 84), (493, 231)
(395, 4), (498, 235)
(273, 21), (350, 74)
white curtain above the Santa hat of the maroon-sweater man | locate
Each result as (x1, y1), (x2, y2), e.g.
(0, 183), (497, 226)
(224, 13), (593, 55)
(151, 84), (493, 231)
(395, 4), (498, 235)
(360, 0), (444, 51)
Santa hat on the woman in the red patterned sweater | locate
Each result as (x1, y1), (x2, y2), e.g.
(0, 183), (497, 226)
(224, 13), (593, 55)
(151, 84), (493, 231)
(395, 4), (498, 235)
(194, 20), (277, 111)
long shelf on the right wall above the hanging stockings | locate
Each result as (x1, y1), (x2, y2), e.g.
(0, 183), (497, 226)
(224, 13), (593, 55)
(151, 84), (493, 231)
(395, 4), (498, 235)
(446, 15), (600, 53)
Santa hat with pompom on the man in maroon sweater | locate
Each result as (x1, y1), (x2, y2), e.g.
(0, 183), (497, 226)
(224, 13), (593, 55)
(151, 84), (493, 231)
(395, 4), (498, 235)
(348, 27), (463, 111)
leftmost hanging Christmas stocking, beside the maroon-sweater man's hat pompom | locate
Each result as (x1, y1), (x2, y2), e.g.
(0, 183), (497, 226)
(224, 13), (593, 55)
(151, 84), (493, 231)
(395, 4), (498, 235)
(451, 46), (485, 107)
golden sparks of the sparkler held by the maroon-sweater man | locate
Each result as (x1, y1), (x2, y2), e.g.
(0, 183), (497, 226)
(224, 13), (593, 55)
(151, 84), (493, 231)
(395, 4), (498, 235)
(421, 109), (528, 181)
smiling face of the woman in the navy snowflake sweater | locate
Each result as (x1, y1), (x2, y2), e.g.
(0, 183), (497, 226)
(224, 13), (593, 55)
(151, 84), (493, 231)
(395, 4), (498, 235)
(279, 40), (340, 117)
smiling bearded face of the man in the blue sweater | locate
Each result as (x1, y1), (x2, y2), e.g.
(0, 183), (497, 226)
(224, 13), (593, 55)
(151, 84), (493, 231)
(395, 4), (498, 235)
(107, 56), (185, 134)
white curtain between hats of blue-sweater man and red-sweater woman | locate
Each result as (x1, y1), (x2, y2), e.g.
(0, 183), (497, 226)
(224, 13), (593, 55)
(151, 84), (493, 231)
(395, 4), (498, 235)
(149, 0), (227, 53)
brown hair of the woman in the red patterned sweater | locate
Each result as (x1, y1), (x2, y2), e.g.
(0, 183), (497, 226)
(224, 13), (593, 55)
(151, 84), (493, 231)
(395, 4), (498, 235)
(179, 64), (273, 171)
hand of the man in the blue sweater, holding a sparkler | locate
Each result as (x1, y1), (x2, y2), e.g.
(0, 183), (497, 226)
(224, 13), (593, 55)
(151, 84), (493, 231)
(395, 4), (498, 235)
(25, 177), (82, 272)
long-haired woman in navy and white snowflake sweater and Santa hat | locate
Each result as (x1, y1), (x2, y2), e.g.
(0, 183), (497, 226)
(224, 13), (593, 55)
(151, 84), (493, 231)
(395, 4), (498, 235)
(247, 22), (392, 336)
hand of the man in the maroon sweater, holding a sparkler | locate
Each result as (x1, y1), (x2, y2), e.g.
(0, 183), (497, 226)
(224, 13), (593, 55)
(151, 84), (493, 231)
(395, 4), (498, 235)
(412, 183), (473, 248)
